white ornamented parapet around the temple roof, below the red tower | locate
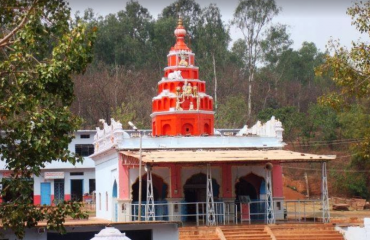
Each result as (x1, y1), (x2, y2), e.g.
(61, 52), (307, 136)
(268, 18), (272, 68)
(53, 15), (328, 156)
(94, 117), (285, 155)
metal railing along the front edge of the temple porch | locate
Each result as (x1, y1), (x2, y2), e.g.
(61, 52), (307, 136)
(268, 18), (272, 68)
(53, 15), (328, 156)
(120, 200), (322, 226)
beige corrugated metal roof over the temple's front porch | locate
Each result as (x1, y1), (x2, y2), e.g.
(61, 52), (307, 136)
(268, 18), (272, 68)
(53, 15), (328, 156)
(121, 150), (336, 163)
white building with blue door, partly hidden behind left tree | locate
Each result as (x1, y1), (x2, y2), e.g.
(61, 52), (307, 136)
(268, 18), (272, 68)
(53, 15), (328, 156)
(0, 130), (96, 205)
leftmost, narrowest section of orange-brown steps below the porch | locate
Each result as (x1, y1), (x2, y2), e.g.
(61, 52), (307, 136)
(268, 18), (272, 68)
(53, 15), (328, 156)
(179, 227), (220, 240)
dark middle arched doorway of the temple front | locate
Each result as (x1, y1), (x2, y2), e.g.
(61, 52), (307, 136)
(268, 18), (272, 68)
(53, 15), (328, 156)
(184, 173), (220, 221)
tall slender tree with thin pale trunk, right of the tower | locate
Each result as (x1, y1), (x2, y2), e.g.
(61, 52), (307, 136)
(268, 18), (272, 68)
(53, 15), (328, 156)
(233, 0), (279, 118)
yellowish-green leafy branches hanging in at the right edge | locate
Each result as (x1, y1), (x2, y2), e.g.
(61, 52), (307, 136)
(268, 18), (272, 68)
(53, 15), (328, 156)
(316, 2), (370, 167)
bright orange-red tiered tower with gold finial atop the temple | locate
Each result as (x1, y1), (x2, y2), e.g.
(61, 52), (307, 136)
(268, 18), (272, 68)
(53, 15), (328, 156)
(151, 18), (214, 136)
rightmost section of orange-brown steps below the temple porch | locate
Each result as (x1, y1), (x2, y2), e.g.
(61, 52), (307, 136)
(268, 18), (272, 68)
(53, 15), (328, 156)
(270, 224), (344, 240)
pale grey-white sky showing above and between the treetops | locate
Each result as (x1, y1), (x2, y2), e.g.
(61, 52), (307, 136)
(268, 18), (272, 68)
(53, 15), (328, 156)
(67, 0), (369, 51)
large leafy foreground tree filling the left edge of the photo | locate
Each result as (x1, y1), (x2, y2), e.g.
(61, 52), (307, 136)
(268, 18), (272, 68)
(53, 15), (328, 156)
(0, 0), (95, 238)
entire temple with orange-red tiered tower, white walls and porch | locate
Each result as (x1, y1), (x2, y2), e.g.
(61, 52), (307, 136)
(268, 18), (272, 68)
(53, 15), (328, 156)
(90, 19), (335, 225)
